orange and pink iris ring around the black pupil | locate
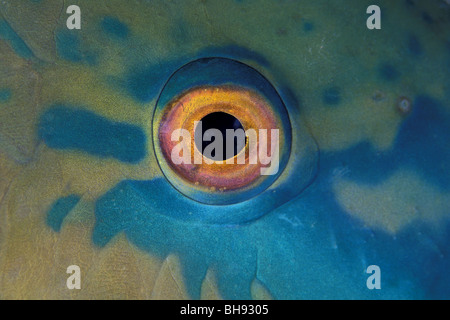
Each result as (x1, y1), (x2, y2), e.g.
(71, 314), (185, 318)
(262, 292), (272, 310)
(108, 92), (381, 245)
(157, 85), (284, 192)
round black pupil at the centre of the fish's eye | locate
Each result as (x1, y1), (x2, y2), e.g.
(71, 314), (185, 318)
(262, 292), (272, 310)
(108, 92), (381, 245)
(195, 112), (246, 161)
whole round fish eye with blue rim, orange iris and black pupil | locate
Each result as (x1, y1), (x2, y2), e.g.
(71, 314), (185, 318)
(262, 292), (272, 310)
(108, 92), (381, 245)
(153, 58), (292, 205)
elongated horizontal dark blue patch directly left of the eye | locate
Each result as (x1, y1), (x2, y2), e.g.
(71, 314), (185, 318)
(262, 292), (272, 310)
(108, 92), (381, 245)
(38, 105), (146, 163)
